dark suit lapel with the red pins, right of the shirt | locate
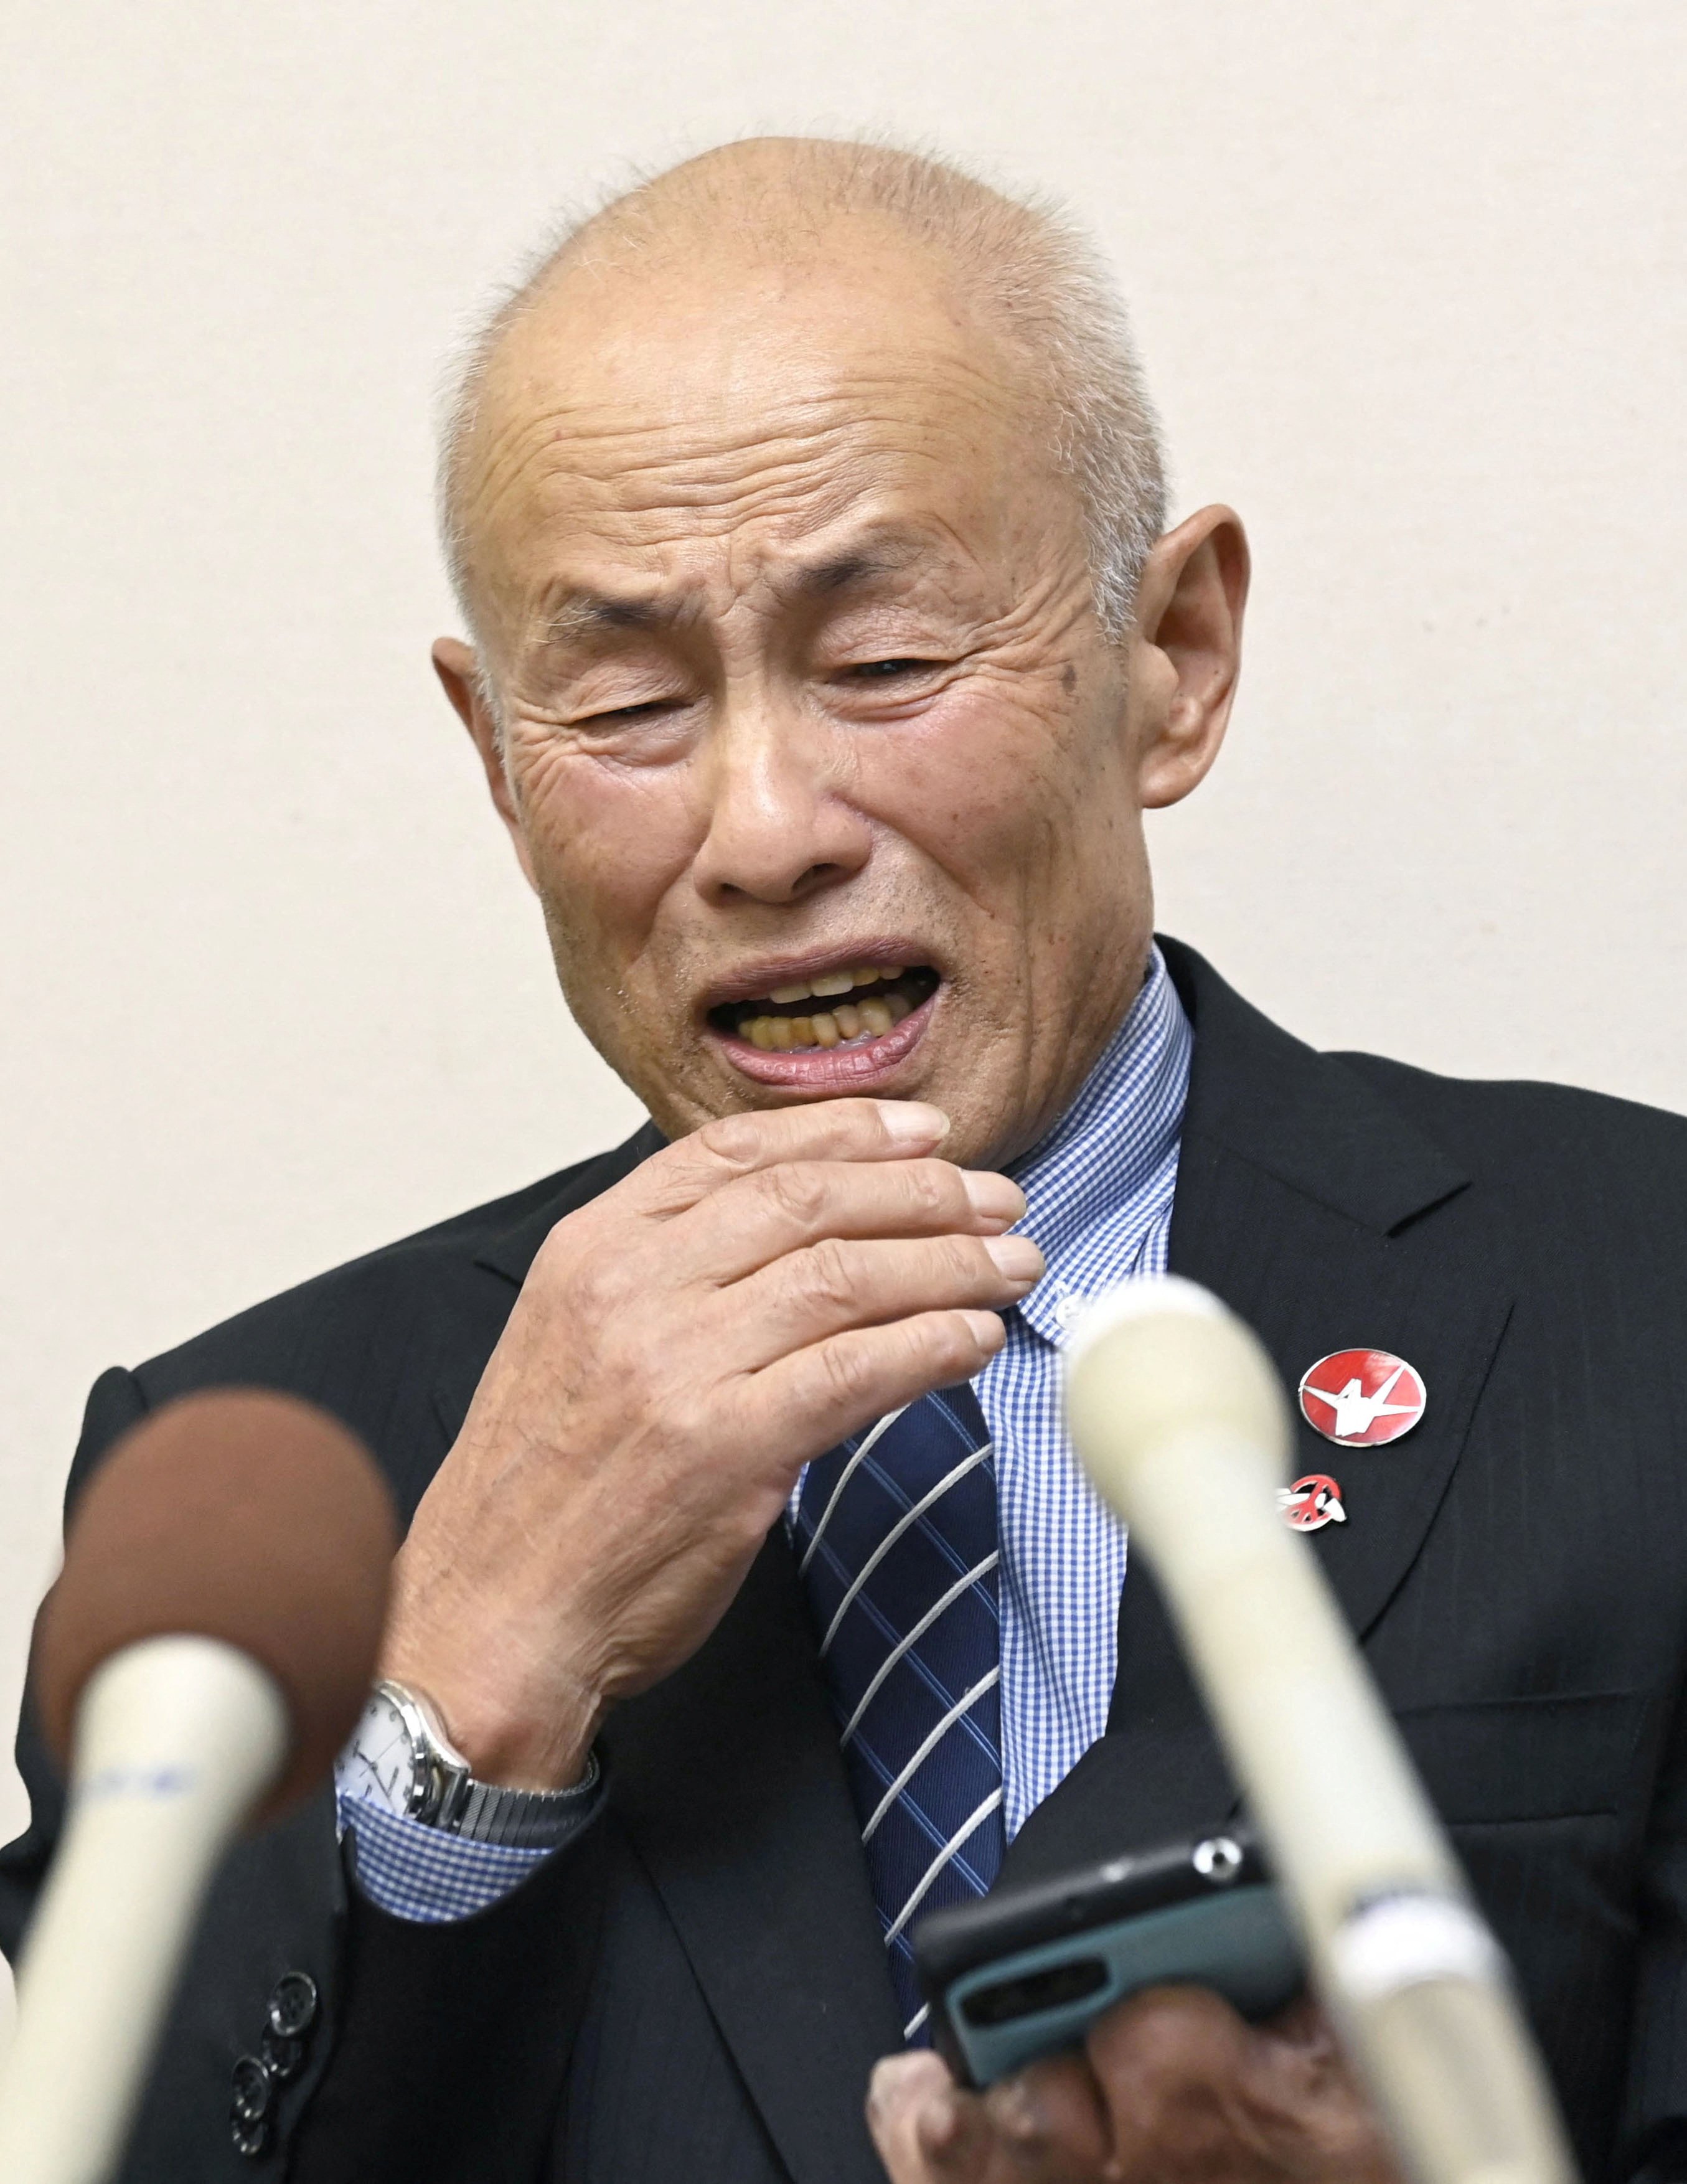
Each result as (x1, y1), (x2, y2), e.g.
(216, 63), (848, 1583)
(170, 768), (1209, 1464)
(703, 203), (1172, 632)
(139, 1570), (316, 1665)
(1004, 941), (1513, 1878)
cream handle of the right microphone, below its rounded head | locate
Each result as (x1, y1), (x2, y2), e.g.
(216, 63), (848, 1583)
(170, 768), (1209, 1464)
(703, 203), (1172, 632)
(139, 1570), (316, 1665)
(1112, 1424), (1576, 2184)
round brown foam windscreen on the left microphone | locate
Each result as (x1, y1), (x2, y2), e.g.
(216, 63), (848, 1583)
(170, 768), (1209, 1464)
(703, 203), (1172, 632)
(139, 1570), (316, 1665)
(31, 1387), (397, 1826)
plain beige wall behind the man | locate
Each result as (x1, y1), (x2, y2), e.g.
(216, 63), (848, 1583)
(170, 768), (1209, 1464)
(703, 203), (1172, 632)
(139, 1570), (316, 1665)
(0, 0), (1687, 2026)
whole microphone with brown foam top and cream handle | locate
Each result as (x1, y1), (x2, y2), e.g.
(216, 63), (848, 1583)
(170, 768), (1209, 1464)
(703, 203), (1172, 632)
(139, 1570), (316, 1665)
(0, 1389), (397, 2184)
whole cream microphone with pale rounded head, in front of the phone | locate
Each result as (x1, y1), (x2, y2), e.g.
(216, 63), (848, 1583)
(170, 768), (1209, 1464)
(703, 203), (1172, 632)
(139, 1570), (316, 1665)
(1067, 1278), (1576, 2184)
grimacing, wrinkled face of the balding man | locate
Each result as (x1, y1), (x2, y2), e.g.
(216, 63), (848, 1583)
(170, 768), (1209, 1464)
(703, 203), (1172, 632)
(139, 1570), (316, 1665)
(447, 223), (1205, 1164)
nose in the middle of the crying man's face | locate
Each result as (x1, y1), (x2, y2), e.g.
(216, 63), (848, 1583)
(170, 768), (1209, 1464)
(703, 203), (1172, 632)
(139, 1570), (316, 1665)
(692, 695), (873, 904)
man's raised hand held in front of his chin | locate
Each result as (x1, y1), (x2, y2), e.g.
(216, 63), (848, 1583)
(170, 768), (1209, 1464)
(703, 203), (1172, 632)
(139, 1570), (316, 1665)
(382, 1101), (1043, 1789)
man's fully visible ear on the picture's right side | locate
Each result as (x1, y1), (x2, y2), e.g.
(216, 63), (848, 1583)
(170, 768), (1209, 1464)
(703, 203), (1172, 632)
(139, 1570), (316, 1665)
(1130, 507), (1248, 810)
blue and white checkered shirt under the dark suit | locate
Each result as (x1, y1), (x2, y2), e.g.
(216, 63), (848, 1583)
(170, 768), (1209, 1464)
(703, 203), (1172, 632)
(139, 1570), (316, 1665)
(338, 948), (1194, 1922)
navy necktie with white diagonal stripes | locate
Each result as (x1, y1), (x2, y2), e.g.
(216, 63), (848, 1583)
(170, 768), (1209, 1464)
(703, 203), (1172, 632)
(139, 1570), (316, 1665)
(794, 1383), (1002, 2040)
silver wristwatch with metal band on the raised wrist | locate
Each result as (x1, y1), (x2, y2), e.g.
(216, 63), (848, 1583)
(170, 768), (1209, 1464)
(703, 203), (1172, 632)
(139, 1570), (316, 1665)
(334, 1677), (598, 1850)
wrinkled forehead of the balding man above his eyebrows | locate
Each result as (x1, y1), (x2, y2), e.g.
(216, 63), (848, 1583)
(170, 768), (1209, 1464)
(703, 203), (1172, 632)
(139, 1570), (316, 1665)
(458, 236), (1076, 620)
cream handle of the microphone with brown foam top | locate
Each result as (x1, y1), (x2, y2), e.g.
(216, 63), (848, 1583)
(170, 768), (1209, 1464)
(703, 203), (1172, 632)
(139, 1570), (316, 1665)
(0, 1636), (290, 2184)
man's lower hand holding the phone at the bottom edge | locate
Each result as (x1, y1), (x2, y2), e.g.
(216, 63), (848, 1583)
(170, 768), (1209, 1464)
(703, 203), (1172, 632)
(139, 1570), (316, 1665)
(867, 1987), (1399, 2184)
